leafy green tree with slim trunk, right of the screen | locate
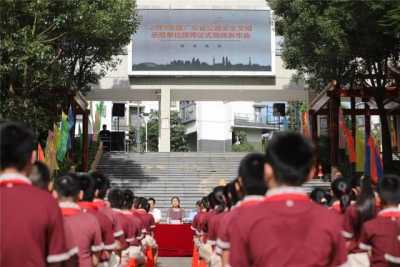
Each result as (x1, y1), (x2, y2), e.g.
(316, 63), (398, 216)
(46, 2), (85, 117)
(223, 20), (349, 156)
(269, 0), (400, 172)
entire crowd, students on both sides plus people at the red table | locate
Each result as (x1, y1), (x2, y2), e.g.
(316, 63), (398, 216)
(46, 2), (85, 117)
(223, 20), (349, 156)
(0, 123), (400, 267)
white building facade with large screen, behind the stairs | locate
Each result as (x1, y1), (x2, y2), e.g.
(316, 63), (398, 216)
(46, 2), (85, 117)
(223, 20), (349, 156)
(87, 0), (307, 152)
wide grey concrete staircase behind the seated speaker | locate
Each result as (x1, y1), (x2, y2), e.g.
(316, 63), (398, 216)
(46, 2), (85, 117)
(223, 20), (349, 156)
(97, 152), (329, 219)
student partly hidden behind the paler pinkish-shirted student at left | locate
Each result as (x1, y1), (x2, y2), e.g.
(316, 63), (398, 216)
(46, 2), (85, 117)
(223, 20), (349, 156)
(78, 173), (117, 264)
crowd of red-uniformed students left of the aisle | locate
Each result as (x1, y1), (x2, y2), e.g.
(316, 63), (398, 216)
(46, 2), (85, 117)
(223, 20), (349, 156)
(0, 123), (157, 267)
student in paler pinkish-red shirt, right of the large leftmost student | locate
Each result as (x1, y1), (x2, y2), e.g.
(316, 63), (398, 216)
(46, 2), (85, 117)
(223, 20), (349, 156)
(53, 174), (103, 267)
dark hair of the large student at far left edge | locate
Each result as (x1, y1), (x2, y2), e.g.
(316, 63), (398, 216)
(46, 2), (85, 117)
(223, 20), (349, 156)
(0, 122), (35, 171)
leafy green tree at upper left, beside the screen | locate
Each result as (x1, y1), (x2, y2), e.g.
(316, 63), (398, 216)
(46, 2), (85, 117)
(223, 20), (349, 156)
(0, 0), (137, 142)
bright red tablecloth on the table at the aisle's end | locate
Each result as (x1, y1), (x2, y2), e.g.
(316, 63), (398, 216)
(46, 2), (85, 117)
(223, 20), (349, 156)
(154, 224), (193, 257)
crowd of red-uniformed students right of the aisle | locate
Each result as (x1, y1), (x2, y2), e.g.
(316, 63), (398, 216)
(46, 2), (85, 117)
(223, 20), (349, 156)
(192, 133), (400, 267)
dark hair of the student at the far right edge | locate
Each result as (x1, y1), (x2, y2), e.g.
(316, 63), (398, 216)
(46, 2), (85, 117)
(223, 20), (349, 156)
(378, 174), (400, 205)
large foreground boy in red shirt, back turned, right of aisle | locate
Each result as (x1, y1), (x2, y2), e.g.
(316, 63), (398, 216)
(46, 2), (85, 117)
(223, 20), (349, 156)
(229, 133), (347, 267)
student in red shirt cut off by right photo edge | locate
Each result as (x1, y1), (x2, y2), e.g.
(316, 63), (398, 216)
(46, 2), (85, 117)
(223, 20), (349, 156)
(360, 175), (400, 267)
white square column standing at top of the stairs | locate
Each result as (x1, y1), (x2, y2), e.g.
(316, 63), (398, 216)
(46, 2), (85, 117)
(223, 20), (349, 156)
(158, 88), (171, 152)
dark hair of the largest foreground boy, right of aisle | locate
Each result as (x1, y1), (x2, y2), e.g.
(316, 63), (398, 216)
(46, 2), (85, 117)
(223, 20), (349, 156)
(266, 132), (315, 186)
